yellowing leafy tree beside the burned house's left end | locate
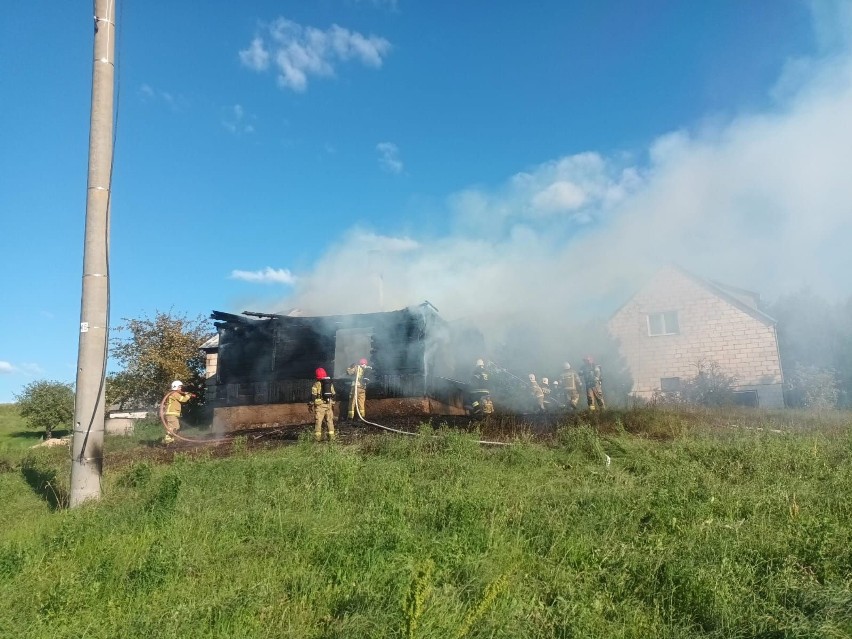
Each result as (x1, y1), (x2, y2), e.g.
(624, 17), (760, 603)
(107, 311), (211, 409)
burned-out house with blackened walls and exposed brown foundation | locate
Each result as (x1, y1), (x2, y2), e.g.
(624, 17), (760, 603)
(208, 302), (483, 430)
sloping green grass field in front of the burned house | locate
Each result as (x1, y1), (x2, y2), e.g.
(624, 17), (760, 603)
(0, 409), (852, 638)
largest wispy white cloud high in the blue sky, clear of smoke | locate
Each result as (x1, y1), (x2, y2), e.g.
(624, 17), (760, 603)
(239, 18), (391, 91)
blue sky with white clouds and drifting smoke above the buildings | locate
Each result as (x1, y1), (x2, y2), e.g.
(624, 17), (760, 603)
(0, 0), (852, 402)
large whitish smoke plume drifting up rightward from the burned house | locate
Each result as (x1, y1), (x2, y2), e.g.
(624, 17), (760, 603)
(231, 4), (852, 370)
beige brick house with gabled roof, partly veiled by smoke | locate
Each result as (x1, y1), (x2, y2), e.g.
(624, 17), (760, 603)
(609, 267), (784, 408)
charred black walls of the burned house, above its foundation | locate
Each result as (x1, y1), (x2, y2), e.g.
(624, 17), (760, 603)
(212, 307), (481, 407)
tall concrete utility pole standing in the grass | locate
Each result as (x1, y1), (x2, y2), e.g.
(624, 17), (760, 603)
(70, 0), (116, 507)
